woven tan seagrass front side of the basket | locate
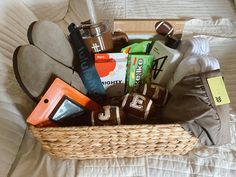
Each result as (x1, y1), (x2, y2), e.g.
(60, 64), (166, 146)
(30, 124), (198, 160)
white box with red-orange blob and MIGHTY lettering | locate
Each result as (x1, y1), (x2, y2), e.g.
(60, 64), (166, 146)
(95, 53), (128, 97)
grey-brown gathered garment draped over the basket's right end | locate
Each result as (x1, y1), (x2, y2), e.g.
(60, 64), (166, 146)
(162, 70), (230, 145)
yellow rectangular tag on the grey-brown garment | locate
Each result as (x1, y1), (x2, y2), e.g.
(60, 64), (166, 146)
(207, 76), (230, 106)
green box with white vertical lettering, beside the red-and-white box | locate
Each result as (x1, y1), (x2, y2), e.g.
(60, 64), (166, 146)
(126, 54), (153, 92)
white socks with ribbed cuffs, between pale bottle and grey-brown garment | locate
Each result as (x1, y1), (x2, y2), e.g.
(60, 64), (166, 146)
(167, 37), (220, 91)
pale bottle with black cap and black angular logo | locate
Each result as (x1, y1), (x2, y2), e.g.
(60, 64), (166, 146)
(150, 36), (182, 87)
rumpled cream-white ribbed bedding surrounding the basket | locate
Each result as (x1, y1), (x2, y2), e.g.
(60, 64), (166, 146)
(0, 0), (236, 177)
